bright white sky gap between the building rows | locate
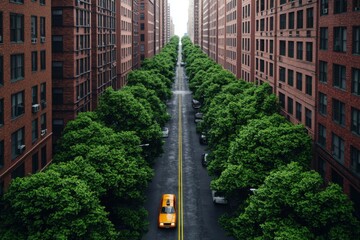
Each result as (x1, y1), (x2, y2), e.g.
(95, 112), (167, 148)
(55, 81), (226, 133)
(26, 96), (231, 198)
(168, 0), (189, 38)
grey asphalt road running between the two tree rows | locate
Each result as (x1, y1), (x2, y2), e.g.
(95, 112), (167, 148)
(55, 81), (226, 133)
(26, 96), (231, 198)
(143, 47), (233, 240)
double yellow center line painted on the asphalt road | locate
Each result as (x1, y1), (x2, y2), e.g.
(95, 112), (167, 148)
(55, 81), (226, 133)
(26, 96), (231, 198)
(178, 89), (184, 240)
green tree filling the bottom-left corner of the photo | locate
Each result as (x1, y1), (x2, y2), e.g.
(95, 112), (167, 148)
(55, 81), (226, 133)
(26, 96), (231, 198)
(0, 169), (116, 240)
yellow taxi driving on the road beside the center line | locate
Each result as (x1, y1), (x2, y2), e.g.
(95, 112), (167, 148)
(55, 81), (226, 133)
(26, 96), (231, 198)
(158, 194), (176, 228)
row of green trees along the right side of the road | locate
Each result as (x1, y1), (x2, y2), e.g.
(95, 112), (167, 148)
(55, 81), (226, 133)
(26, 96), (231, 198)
(182, 37), (360, 240)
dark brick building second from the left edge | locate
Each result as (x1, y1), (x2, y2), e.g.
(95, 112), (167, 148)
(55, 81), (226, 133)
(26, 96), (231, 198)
(51, 0), (92, 144)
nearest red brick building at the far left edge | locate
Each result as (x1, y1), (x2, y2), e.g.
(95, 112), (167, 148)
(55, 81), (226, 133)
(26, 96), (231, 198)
(0, 0), (52, 192)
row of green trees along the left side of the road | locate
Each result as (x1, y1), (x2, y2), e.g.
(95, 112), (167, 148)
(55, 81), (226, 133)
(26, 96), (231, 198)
(0, 37), (179, 240)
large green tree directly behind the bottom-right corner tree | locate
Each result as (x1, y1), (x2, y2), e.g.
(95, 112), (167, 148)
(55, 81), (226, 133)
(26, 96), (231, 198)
(212, 114), (311, 194)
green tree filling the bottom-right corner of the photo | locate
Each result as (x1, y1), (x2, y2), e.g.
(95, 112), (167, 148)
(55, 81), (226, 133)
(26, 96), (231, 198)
(223, 162), (360, 240)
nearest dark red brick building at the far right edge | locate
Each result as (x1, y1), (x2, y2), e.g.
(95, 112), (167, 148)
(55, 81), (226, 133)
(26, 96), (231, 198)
(314, 0), (360, 217)
